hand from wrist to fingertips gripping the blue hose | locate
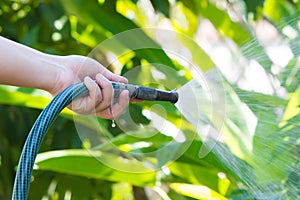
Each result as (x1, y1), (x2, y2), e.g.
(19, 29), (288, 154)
(49, 56), (129, 119)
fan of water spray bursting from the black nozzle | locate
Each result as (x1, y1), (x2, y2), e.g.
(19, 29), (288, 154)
(175, 60), (300, 199)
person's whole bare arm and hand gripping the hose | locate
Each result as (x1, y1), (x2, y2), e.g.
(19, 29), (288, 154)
(0, 36), (129, 119)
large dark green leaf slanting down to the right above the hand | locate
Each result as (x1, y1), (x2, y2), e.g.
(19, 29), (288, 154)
(61, 0), (175, 68)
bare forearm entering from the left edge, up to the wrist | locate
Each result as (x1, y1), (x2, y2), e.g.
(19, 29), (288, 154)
(0, 36), (62, 91)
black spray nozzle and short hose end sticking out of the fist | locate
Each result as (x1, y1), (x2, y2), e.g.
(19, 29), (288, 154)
(112, 82), (178, 104)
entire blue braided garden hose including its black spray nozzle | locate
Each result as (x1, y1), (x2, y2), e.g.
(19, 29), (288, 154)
(12, 82), (178, 200)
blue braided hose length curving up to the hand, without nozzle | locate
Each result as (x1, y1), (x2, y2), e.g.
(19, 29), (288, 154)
(12, 83), (88, 200)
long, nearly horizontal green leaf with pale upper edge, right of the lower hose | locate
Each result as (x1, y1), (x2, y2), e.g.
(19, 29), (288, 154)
(35, 150), (156, 186)
